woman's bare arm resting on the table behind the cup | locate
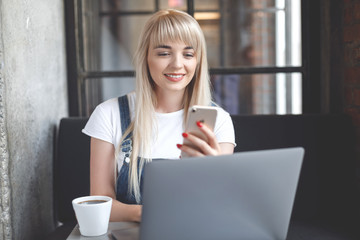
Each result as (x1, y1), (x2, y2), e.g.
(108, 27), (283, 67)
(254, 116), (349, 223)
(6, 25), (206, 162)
(90, 138), (142, 222)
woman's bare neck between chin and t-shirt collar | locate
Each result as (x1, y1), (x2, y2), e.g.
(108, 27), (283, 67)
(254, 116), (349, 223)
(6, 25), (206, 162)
(155, 92), (184, 113)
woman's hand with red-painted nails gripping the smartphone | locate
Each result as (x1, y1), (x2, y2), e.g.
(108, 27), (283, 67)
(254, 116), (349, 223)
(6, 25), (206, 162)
(178, 122), (234, 157)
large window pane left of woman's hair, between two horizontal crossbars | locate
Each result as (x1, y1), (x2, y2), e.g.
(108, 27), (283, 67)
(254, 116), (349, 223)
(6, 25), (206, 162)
(84, 15), (150, 71)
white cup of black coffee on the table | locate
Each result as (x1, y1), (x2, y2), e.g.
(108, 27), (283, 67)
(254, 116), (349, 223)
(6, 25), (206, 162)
(72, 196), (112, 237)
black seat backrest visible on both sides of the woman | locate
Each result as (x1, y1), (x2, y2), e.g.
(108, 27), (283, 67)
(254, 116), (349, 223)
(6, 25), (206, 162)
(54, 115), (358, 227)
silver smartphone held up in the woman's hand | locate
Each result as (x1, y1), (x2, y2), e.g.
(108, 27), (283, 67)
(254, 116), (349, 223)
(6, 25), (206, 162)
(181, 105), (218, 158)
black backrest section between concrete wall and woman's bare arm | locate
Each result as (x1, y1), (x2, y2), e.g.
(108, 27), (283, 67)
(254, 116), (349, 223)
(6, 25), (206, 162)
(54, 118), (90, 222)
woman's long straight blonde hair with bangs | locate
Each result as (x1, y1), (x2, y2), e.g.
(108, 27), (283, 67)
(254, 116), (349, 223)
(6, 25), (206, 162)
(119, 9), (211, 203)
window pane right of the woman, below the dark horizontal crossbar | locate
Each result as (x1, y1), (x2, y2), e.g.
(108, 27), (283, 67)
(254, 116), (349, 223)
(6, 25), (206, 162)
(211, 73), (302, 114)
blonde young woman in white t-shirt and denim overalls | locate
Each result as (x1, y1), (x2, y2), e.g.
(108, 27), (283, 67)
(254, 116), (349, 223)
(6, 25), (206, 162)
(83, 10), (235, 222)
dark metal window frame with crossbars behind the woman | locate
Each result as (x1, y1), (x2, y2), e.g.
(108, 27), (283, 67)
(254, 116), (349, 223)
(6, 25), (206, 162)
(64, 0), (321, 116)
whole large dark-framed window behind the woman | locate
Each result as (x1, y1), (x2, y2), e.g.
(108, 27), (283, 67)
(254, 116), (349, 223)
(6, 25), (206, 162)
(66, 0), (309, 116)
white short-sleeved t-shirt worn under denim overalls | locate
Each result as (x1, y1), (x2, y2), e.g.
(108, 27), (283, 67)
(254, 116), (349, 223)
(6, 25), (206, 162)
(82, 92), (235, 169)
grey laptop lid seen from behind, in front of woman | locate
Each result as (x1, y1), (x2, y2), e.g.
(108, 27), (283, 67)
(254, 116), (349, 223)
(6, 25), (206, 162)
(140, 148), (304, 240)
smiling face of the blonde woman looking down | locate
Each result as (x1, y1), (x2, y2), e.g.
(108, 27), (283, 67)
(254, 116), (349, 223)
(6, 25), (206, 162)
(147, 42), (197, 93)
